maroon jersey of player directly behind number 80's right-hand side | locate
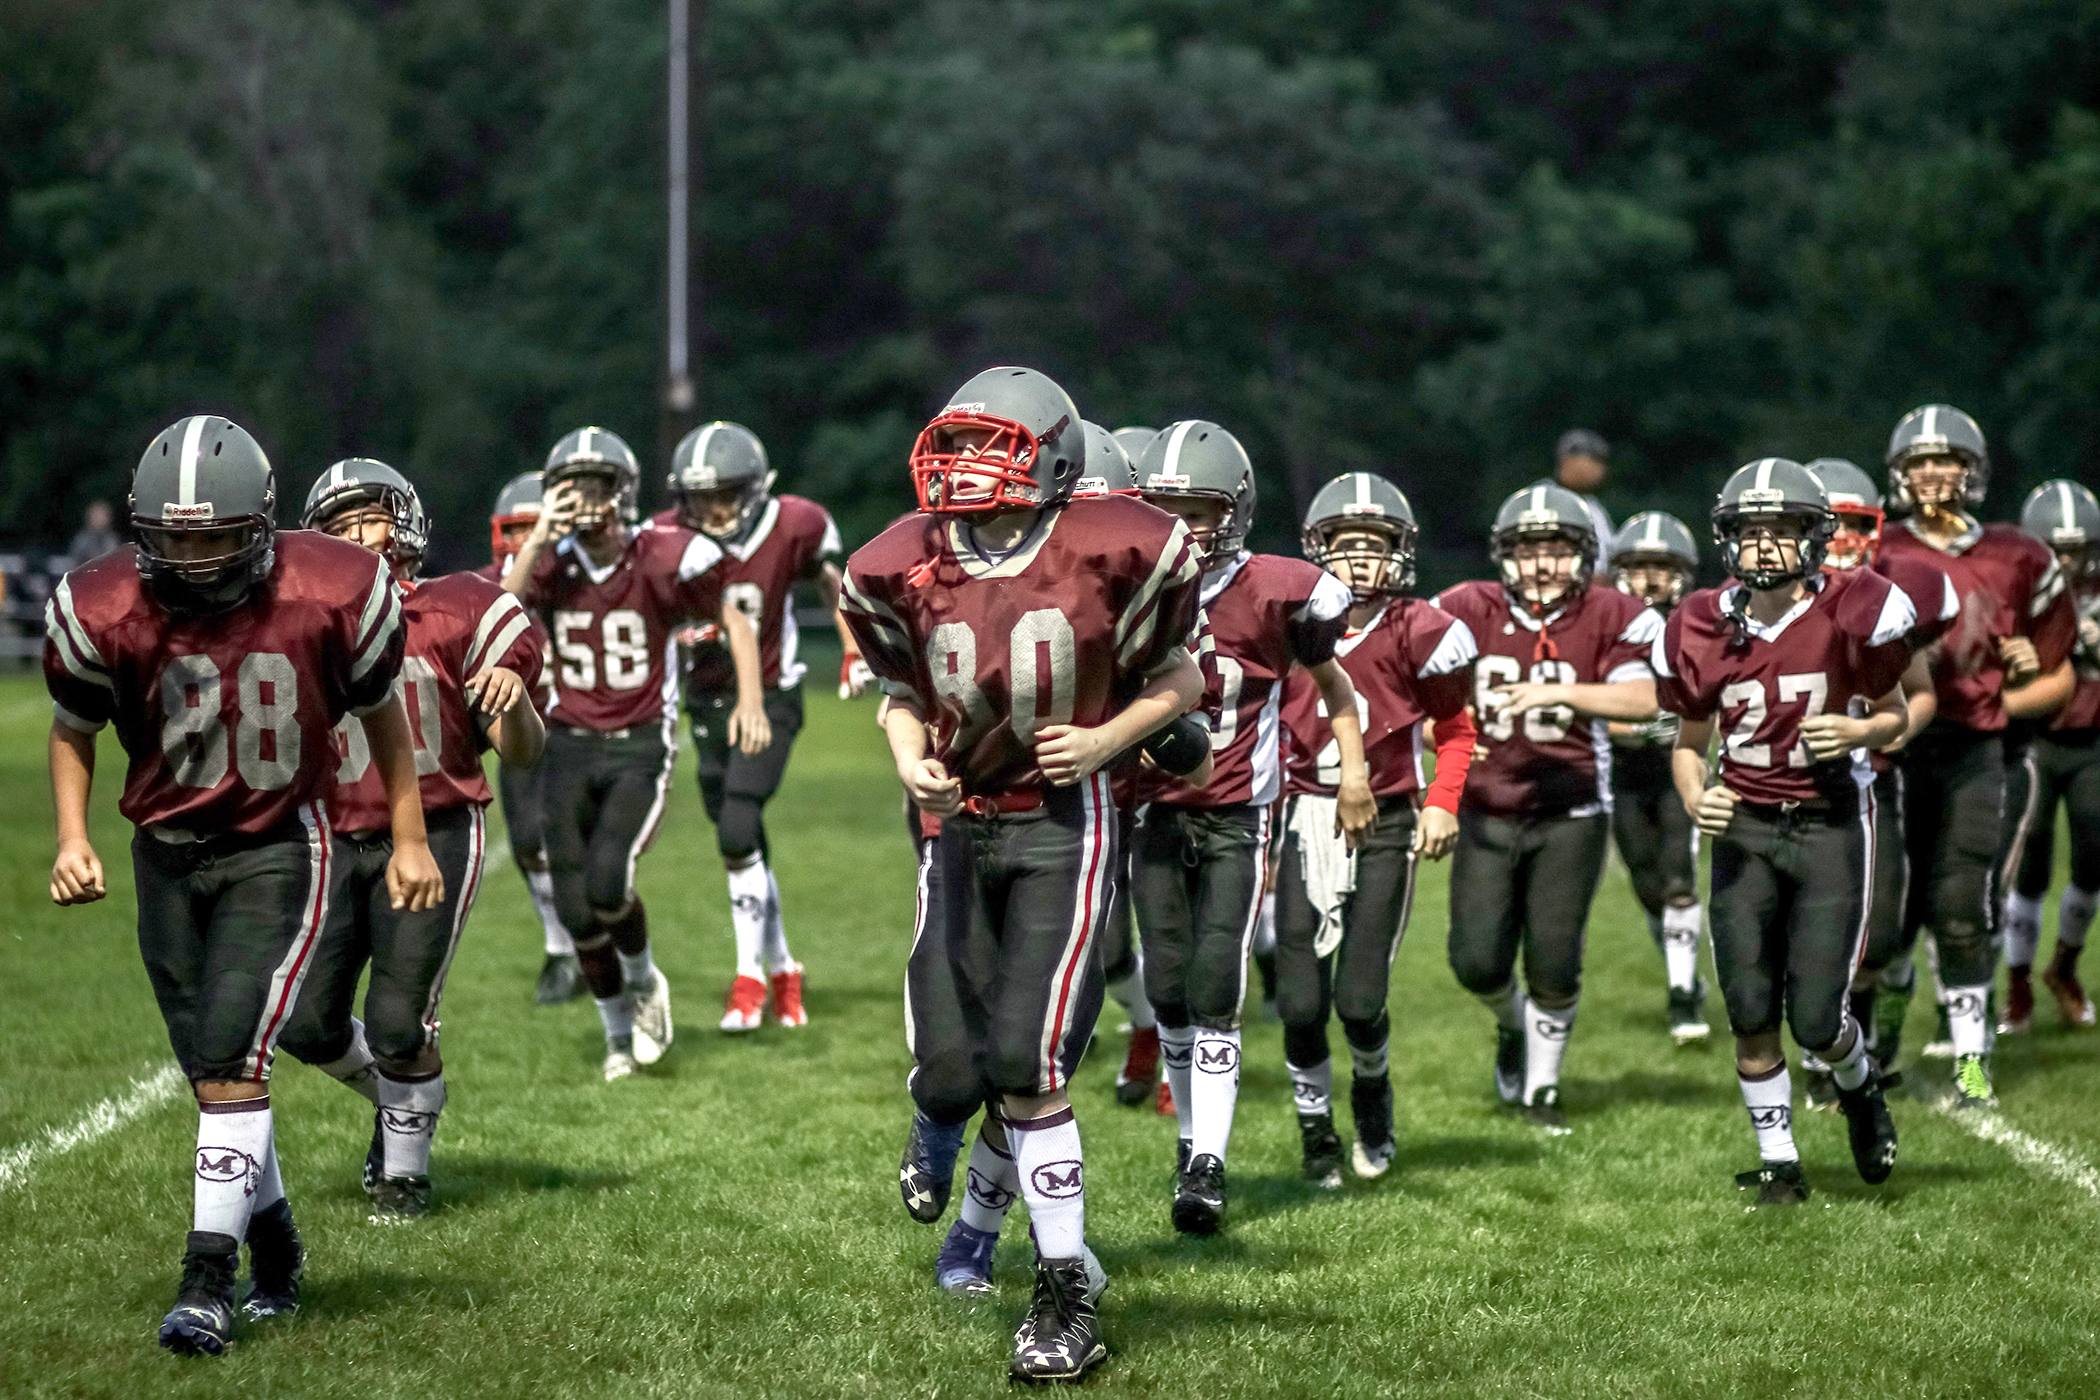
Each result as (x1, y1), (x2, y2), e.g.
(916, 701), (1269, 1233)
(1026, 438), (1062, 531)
(1147, 554), (1352, 808)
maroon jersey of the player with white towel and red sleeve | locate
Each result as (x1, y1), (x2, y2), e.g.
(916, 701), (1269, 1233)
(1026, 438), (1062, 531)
(1283, 598), (1478, 798)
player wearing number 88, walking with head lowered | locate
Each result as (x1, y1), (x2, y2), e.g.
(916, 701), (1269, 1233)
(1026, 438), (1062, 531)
(44, 416), (445, 1356)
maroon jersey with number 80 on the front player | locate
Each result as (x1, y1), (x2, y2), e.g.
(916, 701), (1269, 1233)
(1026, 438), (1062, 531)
(840, 495), (1201, 798)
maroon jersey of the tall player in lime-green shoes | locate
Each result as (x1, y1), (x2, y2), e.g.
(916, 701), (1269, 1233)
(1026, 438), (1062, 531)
(1877, 521), (2077, 733)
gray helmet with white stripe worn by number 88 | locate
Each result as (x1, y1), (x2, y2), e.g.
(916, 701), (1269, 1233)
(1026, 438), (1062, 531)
(130, 413), (277, 613)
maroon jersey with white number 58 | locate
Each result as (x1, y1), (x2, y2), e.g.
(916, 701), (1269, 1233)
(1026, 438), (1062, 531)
(523, 527), (722, 739)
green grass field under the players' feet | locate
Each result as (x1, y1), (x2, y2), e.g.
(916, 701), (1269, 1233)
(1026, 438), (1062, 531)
(0, 667), (2100, 1400)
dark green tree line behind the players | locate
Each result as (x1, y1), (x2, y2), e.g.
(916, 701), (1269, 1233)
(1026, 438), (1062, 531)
(0, 0), (2100, 581)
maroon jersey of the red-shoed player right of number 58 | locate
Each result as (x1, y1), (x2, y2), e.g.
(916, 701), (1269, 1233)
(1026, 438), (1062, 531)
(649, 495), (844, 691)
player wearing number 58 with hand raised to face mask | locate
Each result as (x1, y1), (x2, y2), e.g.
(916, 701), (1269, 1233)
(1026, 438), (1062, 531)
(504, 428), (771, 1081)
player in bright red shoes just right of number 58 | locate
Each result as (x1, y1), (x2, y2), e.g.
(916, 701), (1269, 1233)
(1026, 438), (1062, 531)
(651, 422), (853, 1031)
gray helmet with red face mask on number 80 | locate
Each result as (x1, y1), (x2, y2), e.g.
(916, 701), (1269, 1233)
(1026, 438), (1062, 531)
(911, 365), (1086, 514)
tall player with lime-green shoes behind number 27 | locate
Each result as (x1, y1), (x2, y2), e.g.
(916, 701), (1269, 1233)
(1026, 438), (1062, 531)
(1882, 403), (2077, 1108)
